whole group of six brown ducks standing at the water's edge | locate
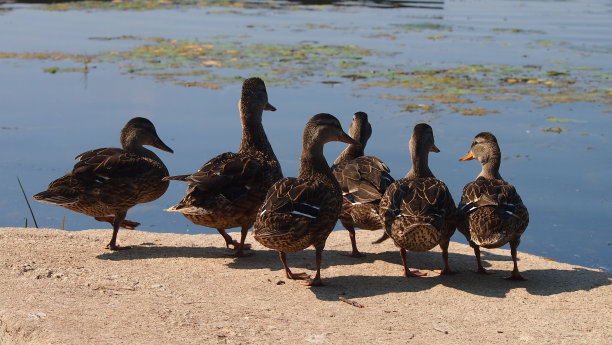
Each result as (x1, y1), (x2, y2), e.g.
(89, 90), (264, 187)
(33, 78), (529, 286)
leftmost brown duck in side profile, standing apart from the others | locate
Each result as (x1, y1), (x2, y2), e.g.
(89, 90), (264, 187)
(33, 117), (173, 250)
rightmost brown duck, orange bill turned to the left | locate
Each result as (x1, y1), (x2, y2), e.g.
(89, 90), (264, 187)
(458, 132), (529, 280)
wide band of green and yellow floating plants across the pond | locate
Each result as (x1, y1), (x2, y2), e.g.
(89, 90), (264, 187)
(0, 35), (612, 115)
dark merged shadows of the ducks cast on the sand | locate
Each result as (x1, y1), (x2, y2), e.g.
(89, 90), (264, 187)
(97, 243), (612, 301)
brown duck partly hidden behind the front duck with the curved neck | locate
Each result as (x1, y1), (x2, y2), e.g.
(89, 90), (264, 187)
(332, 112), (395, 257)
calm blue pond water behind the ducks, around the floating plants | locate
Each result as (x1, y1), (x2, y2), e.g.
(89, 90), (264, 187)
(0, 1), (612, 271)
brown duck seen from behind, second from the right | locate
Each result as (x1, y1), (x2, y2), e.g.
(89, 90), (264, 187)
(380, 123), (456, 276)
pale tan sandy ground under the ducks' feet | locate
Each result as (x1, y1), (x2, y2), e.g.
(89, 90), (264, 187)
(0, 228), (612, 344)
